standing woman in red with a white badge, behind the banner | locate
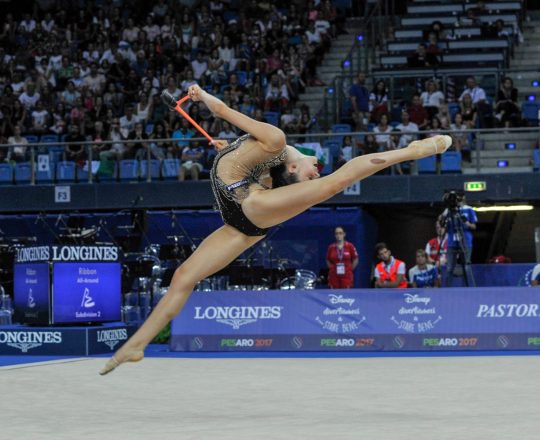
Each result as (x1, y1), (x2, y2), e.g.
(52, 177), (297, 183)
(326, 226), (358, 289)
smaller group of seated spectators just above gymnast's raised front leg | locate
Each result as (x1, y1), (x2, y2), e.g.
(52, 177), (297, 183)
(342, 72), (525, 174)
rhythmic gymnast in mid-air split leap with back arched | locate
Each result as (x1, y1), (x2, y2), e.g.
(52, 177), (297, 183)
(100, 85), (452, 375)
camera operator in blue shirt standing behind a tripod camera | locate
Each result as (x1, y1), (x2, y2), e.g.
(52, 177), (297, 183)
(439, 191), (478, 287)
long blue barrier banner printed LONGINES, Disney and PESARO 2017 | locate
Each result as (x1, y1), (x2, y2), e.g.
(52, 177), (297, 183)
(171, 287), (540, 351)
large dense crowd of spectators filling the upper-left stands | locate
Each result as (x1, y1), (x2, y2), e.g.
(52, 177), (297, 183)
(0, 0), (343, 178)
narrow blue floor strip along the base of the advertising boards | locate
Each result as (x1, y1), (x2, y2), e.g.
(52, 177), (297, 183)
(0, 345), (540, 367)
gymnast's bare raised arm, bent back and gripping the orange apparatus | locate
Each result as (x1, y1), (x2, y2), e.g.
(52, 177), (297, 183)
(188, 85), (286, 153)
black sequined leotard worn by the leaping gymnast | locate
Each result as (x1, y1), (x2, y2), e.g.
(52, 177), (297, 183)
(210, 134), (286, 236)
